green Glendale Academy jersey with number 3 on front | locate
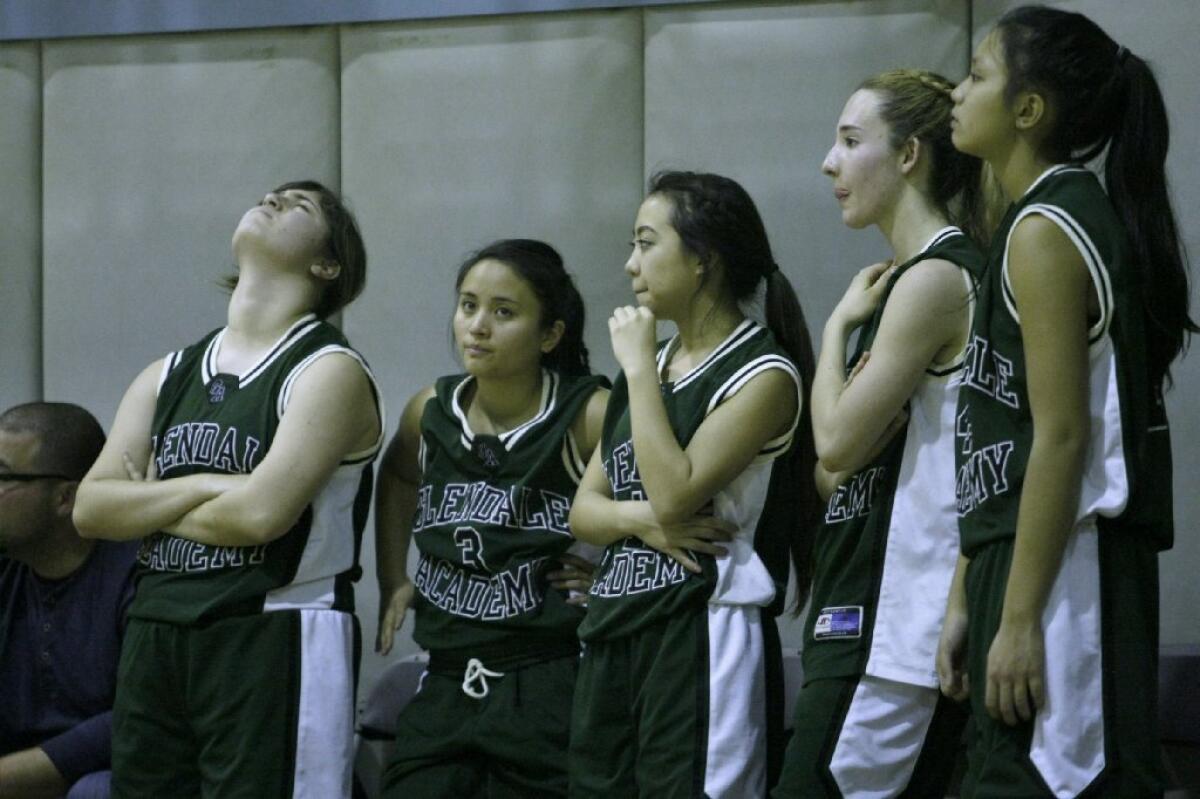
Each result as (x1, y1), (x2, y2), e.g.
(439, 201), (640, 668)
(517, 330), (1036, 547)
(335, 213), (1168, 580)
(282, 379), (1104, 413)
(413, 370), (607, 668)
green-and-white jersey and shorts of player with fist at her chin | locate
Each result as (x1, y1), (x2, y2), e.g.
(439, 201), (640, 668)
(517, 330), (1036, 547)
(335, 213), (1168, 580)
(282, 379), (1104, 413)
(571, 319), (803, 799)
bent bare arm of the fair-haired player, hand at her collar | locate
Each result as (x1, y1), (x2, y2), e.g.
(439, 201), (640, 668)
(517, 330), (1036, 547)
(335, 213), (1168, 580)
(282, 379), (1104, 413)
(812, 259), (970, 471)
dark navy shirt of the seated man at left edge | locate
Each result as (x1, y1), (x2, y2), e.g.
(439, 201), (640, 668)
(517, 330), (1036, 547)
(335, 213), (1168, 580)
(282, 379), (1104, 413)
(0, 541), (138, 782)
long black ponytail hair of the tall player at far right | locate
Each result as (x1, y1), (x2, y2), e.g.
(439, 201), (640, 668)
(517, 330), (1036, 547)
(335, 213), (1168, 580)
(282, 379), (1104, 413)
(996, 6), (1200, 385)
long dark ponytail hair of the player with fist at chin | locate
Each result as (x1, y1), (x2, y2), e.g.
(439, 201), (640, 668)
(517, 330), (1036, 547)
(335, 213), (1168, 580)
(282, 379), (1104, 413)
(649, 172), (822, 612)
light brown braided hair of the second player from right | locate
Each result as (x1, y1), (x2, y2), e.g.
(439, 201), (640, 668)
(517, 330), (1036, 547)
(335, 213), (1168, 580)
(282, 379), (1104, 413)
(858, 70), (986, 245)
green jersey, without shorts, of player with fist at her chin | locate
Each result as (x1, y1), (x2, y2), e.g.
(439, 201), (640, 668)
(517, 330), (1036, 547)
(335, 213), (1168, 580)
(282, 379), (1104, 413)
(580, 319), (803, 641)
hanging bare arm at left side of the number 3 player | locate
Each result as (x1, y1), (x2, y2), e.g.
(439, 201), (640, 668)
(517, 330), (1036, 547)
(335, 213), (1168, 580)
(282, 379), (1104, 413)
(376, 386), (433, 655)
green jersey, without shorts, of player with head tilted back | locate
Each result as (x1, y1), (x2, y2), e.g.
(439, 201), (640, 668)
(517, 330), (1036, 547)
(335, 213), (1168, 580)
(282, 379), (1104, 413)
(130, 314), (383, 624)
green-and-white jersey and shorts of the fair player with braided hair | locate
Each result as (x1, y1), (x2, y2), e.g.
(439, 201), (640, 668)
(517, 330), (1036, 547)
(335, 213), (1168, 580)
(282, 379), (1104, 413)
(774, 227), (984, 798)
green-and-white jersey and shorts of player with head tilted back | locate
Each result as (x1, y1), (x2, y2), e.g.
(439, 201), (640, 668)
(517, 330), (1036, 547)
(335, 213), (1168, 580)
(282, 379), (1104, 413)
(113, 314), (384, 799)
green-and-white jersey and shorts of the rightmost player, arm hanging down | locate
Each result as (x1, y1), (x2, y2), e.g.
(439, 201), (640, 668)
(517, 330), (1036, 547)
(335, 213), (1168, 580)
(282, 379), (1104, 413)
(955, 164), (1174, 797)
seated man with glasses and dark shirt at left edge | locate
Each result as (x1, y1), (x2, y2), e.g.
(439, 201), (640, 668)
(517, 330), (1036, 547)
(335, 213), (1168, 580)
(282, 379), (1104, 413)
(0, 402), (137, 799)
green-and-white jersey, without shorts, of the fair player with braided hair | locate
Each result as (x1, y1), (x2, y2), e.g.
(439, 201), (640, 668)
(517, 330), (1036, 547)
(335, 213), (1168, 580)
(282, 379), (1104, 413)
(803, 227), (984, 686)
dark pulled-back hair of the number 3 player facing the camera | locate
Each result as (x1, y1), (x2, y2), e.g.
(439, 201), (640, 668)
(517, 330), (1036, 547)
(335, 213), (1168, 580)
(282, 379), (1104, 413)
(454, 239), (590, 374)
